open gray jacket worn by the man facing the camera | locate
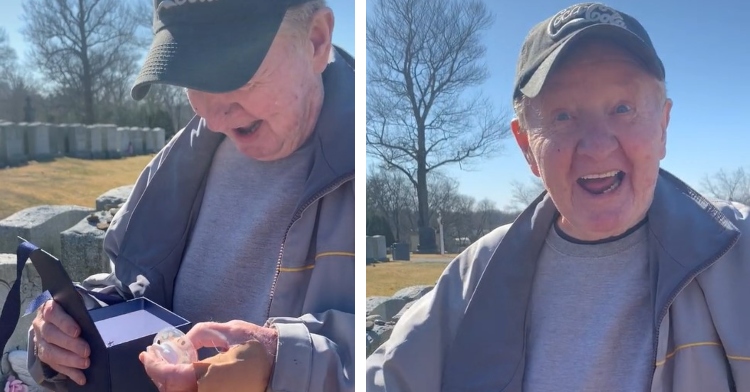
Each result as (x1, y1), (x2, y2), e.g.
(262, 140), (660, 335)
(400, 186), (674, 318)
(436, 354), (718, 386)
(366, 170), (750, 392)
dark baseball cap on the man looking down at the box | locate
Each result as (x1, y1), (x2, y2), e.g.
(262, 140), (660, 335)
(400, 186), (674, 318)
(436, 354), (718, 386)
(130, 0), (309, 100)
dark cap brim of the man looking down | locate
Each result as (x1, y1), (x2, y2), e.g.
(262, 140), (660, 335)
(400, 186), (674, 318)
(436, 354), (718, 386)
(130, 9), (285, 101)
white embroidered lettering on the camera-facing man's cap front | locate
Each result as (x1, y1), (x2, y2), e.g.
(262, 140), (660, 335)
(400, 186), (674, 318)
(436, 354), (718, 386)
(547, 3), (628, 39)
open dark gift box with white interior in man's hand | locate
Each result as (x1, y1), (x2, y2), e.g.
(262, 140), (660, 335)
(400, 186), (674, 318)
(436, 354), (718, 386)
(29, 240), (191, 392)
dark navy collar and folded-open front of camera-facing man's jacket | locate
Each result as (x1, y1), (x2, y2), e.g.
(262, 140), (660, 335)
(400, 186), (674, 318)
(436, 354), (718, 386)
(443, 170), (739, 391)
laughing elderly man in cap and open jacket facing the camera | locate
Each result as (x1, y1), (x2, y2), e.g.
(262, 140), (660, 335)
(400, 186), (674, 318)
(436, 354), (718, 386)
(366, 3), (750, 392)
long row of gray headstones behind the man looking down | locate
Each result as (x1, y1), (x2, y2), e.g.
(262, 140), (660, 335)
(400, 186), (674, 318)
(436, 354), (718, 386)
(0, 121), (165, 167)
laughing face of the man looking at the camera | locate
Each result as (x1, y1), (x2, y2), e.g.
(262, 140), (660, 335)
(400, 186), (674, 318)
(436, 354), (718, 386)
(512, 42), (672, 240)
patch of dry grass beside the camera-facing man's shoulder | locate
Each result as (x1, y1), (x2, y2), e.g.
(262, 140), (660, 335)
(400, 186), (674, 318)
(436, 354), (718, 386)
(367, 255), (453, 297)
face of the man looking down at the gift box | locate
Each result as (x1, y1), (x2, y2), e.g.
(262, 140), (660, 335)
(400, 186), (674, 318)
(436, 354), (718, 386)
(187, 10), (333, 161)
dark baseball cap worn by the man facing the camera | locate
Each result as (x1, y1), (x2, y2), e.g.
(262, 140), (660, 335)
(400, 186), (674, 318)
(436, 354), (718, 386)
(513, 3), (665, 99)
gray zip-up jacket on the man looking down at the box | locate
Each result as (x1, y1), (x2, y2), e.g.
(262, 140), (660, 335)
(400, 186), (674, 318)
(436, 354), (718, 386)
(29, 48), (355, 392)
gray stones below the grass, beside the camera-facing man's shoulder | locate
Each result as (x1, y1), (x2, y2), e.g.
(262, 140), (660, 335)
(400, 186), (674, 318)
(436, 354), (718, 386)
(366, 286), (434, 357)
